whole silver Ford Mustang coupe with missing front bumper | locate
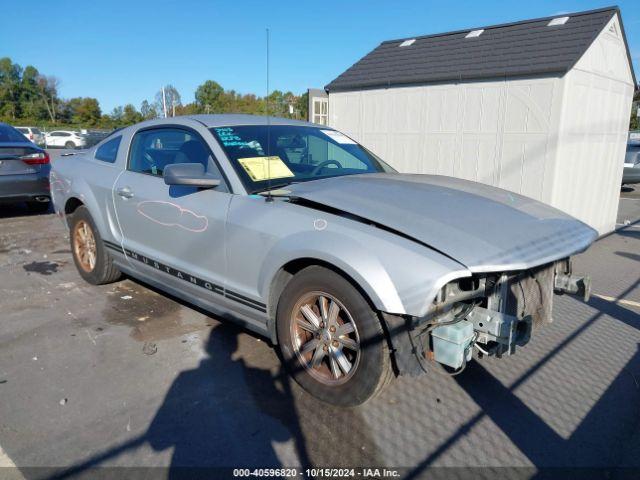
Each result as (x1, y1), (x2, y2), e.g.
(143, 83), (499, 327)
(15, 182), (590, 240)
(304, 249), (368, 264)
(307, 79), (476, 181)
(51, 115), (596, 406)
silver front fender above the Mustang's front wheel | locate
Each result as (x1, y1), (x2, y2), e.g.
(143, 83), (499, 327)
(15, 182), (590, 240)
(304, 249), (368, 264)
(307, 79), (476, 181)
(258, 212), (471, 316)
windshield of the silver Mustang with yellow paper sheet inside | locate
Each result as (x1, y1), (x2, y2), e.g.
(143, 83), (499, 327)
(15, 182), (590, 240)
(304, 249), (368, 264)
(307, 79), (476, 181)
(211, 125), (394, 193)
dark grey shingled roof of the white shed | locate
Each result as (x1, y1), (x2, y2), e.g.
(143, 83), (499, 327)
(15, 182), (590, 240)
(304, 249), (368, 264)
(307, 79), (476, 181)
(325, 7), (635, 91)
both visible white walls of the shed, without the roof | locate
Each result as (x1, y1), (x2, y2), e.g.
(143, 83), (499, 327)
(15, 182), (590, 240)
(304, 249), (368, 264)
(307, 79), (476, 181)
(329, 13), (633, 234)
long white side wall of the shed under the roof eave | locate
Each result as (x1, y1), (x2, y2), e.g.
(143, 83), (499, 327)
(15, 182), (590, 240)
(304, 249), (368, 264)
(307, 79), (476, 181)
(329, 78), (562, 201)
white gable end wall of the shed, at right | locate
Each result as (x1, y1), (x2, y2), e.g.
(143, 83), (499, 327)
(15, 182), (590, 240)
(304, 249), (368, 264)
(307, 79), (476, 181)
(551, 16), (633, 233)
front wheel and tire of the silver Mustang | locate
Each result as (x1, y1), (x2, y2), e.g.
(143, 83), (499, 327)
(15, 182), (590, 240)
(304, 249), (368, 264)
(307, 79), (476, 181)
(276, 266), (393, 406)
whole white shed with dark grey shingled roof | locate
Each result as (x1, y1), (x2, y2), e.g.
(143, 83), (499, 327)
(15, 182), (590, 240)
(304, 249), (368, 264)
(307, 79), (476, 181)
(325, 7), (636, 234)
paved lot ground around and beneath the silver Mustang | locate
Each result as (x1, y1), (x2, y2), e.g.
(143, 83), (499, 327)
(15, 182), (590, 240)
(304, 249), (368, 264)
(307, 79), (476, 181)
(0, 193), (640, 478)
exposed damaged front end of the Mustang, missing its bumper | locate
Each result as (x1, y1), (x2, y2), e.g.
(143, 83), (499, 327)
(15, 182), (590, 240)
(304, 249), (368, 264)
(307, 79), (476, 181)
(384, 259), (590, 375)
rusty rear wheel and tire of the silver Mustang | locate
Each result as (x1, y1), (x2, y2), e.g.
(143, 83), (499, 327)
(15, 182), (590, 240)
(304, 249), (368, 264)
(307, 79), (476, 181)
(69, 206), (122, 285)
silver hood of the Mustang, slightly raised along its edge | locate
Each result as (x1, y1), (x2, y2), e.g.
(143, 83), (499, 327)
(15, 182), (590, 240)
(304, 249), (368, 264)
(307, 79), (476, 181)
(287, 173), (597, 272)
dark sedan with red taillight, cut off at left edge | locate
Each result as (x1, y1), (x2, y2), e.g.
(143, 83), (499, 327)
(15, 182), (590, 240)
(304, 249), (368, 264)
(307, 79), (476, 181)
(0, 123), (50, 211)
